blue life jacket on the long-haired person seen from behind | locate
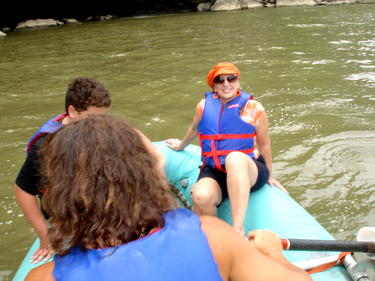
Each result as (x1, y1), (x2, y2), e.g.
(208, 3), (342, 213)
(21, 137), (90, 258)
(53, 209), (222, 281)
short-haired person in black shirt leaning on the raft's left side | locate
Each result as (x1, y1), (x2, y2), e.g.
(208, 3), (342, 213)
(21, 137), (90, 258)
(14, 77), (164, 263)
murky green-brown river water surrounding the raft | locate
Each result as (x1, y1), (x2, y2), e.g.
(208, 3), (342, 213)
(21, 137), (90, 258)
(0, 5), (375, 281)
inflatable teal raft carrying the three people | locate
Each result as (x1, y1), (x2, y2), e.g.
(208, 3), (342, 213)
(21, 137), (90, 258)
(13, 142), (352, 281)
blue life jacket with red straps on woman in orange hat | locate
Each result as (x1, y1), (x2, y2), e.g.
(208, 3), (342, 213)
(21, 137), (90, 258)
(198, 91), (255, 171)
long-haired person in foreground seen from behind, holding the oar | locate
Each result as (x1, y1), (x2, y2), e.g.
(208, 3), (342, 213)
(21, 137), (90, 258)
(25, 115), (311, 281)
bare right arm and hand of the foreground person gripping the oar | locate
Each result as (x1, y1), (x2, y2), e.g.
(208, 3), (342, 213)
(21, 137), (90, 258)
(200, 216), (312, 281)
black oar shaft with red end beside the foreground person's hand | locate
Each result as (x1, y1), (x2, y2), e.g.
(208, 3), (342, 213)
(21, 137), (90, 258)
(281, 238), (375, 253)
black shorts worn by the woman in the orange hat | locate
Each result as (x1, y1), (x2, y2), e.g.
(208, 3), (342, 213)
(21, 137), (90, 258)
(197, 155), (270, 205)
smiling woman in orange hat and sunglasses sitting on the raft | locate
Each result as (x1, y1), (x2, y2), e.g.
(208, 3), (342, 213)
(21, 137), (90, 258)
(166, 62), (288, 235)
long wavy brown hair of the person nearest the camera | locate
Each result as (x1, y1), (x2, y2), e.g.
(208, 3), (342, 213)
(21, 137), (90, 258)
(40, 115), (174, 255)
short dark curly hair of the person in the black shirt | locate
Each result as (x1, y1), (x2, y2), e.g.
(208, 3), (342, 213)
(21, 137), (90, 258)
(65, 77), (111, 112)
